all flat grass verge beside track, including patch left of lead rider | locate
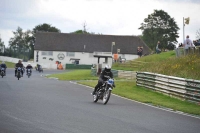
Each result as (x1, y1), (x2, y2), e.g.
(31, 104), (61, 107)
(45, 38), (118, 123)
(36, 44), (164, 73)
(48, 70), (200, 115)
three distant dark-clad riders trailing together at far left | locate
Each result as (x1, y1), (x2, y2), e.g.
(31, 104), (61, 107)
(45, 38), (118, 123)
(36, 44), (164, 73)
(0, 60), (33, 76)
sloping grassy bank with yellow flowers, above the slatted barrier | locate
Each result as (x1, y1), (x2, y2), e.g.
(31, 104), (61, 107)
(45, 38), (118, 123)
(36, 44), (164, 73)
(113, 51), (200, 80)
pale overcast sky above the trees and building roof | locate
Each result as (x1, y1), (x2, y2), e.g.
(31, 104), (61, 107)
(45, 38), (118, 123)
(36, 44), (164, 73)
(0, 0), (200, 47)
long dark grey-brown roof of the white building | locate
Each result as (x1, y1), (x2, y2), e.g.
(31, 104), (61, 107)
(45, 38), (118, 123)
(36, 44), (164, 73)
(35, 32), (150, 54)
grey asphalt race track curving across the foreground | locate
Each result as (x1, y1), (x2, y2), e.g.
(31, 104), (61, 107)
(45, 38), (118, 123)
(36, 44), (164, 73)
(0, 69), (200, 133)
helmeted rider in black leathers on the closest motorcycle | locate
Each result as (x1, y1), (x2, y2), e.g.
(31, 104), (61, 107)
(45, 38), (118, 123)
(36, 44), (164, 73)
(92, 65), (115, 95)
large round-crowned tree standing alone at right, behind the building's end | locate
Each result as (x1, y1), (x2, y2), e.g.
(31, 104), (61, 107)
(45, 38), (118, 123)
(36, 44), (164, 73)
(139, 10), (179, 49)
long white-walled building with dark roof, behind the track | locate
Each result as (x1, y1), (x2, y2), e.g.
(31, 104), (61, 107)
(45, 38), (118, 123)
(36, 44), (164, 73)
(34, 32), (150, 69)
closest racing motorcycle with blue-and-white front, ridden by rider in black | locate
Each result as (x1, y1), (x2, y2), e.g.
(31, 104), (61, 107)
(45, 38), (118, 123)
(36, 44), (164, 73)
(93, 78), (114, 104)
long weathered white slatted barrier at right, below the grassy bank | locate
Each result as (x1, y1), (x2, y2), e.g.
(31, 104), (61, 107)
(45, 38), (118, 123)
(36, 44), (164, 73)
(136, 72), (200, 104)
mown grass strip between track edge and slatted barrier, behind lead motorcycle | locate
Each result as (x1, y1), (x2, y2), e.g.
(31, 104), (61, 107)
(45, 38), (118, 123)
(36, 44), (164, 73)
(79, 81), (200, 115)
